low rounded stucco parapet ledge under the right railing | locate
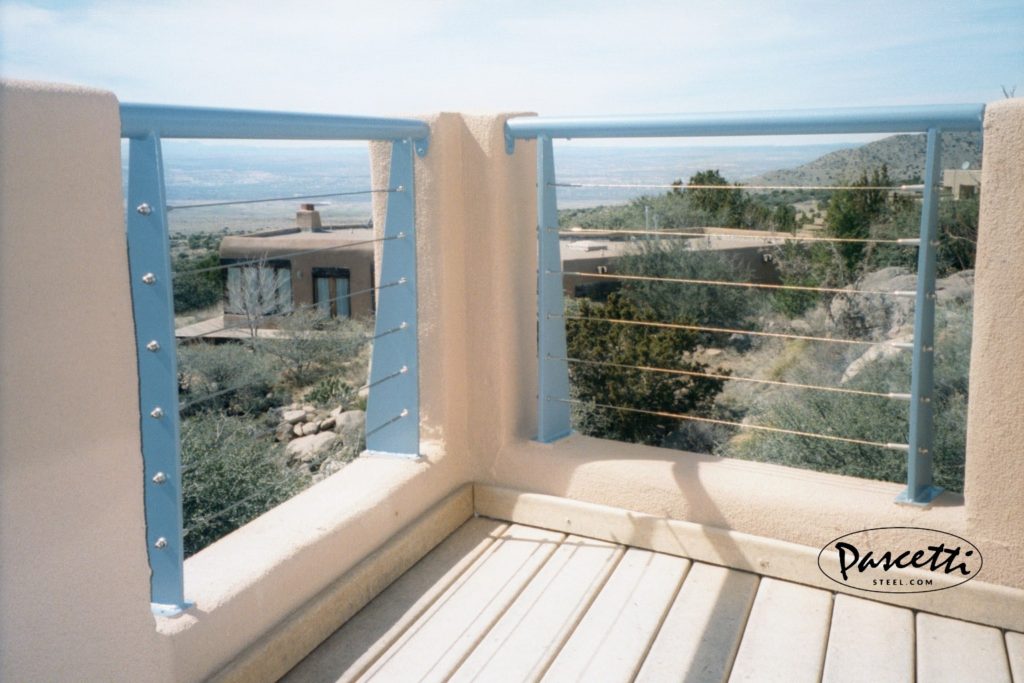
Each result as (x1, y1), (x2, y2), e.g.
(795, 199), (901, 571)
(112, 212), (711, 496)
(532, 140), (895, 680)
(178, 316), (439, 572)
(478, 434), (1024, 589)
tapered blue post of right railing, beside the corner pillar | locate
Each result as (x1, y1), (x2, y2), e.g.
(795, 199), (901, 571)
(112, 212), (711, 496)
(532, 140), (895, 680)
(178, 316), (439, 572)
(537, 135), (570, 443)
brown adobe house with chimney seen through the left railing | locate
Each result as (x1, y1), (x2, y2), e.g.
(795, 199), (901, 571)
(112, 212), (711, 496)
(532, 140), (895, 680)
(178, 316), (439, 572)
(220, 204), (375, 327)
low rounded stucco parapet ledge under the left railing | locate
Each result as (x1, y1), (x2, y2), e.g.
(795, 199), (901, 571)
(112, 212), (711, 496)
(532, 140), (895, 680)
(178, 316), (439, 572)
(157, 446), (466, 681)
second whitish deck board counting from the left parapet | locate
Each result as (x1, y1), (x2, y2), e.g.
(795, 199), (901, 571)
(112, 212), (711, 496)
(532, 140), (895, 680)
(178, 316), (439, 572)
(359, 524), (565, 681)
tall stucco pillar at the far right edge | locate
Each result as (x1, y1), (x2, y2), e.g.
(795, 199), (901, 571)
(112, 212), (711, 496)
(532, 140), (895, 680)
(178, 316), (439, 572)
(965, 98), (1024, 548)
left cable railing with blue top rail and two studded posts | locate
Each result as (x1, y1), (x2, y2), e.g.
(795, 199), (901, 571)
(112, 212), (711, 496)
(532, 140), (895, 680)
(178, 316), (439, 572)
(121, 103), (429, 614)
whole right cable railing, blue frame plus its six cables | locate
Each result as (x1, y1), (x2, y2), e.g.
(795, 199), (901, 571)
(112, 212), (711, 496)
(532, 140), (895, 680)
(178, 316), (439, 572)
(505, 104), (984, 505)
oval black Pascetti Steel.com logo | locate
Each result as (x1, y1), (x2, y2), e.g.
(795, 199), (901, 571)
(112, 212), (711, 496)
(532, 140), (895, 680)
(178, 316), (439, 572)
(818, 526), (983, 593)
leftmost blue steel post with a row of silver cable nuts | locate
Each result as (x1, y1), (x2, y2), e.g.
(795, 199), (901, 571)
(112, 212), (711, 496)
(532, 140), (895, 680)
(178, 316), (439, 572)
(127, 133), (187, 614)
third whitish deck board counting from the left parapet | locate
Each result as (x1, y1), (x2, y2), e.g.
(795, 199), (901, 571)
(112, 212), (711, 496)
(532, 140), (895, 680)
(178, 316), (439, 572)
(452, 537), (626, 683)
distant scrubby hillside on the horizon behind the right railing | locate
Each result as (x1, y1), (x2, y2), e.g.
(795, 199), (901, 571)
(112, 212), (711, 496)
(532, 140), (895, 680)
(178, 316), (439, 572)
(745, 133), (981, 185)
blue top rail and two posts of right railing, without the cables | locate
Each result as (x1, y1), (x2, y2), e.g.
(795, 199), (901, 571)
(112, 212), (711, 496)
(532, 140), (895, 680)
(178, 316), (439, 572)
(505, 104), (985, 505)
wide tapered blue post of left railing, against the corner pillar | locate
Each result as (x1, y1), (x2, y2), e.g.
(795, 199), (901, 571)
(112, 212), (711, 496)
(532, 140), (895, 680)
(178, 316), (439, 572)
(367, 140), (420, 458)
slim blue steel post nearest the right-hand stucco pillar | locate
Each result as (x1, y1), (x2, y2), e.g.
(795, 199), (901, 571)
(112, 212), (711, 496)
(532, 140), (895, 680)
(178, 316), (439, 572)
(896, 128), (942, 505)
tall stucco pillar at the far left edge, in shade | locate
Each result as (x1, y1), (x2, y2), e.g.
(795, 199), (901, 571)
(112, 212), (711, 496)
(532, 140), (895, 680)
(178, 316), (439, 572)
(0, 81), (159, 681)
